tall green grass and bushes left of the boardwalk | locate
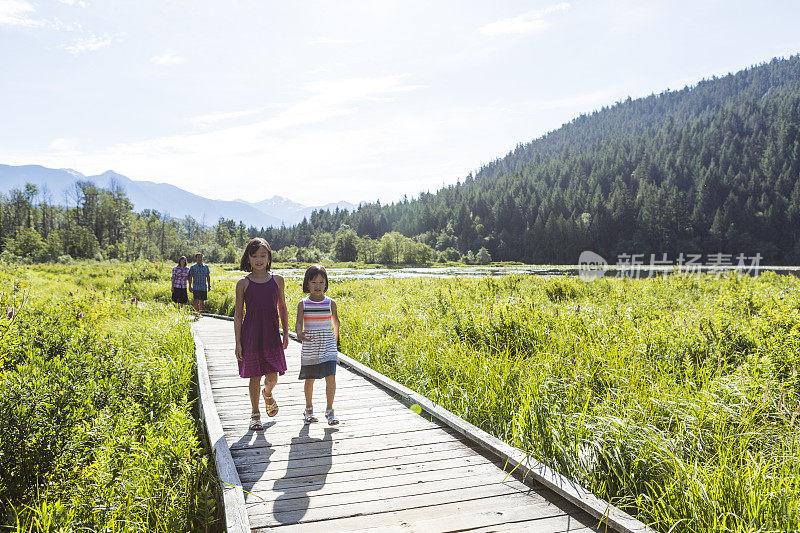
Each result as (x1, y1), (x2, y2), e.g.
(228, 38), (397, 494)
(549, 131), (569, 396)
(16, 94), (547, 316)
(0, 266), (220, 532)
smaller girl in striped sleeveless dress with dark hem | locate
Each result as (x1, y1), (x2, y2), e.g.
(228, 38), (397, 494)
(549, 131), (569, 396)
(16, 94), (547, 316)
(294, 265), (339, 425)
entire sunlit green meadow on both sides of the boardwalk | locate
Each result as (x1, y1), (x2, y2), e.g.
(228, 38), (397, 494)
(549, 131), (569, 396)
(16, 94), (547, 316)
(0, 263), (800, 532)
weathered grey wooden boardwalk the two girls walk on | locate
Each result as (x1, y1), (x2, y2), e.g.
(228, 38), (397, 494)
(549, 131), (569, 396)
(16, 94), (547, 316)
(193, 317), (644, 533)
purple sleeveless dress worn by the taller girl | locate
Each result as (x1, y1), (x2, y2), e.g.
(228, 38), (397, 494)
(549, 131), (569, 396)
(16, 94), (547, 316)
(239, 277), (286, 378)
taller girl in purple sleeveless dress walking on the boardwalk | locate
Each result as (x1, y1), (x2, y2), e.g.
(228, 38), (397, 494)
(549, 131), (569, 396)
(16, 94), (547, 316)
(233, 237), (289, 430)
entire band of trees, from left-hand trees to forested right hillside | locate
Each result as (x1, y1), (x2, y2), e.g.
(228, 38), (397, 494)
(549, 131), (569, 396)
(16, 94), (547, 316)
(0, 56), (800, 264)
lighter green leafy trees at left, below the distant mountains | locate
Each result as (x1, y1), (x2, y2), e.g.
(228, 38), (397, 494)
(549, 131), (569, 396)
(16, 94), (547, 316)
(0, 181), (491, 264)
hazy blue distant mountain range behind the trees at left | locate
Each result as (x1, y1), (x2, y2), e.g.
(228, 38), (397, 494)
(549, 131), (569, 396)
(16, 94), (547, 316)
(0, 165), (358, 228)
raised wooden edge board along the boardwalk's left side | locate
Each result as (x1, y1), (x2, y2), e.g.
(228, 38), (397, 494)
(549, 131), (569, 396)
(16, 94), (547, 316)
(192, 325), (250, 533)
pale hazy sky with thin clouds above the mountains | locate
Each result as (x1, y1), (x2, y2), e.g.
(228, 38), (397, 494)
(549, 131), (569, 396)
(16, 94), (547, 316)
(0, 0), (800, 205)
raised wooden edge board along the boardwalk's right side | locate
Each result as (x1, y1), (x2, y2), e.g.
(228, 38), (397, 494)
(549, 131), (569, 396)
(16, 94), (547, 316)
(198, 313), (655, 533)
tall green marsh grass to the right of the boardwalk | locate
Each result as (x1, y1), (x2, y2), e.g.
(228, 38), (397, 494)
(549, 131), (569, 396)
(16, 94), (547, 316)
(329, 274), (800, 531)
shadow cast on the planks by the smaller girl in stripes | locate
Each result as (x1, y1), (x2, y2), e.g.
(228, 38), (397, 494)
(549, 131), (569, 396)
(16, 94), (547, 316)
(272, 425), (338, 524)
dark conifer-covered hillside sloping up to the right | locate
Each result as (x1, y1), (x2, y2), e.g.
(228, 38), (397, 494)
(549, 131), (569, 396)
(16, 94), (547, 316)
(263, 56), (800, 263)
